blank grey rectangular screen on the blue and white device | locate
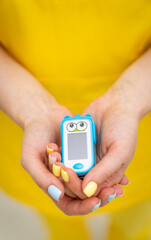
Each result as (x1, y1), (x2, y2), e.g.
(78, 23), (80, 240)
(67, 132), (88, 160)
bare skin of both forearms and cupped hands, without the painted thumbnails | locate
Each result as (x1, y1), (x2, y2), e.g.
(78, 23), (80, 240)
(0, 45), (151, 215)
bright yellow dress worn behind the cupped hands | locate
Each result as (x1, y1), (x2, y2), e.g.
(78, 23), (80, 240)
(0, 0), (151, 240)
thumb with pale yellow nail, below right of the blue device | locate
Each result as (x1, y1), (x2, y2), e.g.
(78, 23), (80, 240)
(82, 146), (126, 197)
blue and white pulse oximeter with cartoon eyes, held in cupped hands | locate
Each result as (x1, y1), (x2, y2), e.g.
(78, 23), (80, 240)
(61, 114), (97, 178)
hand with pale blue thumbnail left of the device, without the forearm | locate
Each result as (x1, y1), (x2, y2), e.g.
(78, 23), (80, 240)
(21, 104), (102, 215)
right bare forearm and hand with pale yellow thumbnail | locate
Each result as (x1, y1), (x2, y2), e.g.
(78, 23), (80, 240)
(82, 49), (151, 201)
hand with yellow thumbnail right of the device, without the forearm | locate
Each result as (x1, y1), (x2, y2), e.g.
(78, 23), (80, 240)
(82, 93), (139, 198)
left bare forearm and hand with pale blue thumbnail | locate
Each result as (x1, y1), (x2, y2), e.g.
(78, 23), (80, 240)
(0, 47), (122, 215)
